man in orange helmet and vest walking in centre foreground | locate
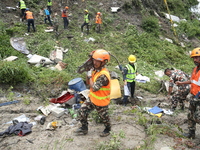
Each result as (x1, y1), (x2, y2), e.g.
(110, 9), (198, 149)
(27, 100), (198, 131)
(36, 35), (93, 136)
(75, 49), (111, 137)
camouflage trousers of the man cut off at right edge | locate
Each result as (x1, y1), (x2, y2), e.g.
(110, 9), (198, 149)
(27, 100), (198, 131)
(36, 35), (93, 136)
(188, 97), (200, 130)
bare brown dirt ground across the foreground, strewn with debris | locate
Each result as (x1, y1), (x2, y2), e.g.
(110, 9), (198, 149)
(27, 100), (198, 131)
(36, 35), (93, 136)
(0, 87), (200, 150)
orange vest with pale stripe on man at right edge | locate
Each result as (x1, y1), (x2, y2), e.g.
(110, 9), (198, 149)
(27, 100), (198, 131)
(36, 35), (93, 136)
(190, 67), (200, 95)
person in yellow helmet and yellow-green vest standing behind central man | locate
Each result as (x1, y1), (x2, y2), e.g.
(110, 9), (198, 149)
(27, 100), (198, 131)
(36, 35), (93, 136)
(123, 55), (137, 106)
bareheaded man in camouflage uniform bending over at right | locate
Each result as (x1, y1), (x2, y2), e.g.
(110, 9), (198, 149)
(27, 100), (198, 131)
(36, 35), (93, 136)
(164, 68), (190, 110)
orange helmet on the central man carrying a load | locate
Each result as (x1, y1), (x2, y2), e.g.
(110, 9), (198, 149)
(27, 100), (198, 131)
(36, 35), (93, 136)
(92, 49), (110, 62)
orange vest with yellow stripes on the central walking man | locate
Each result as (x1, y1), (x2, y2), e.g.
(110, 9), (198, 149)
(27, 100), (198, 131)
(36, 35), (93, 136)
(89, 68), (111, 106)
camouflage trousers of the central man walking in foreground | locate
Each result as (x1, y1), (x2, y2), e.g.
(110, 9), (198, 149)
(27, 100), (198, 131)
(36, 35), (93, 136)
(78, 99), (111, 127)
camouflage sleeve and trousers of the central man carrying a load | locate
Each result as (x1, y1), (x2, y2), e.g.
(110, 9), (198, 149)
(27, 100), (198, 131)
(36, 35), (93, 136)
(78, 75), (111, 128)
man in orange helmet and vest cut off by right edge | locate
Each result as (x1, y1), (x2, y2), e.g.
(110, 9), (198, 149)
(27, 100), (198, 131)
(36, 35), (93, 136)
(176, 47), (200, 139)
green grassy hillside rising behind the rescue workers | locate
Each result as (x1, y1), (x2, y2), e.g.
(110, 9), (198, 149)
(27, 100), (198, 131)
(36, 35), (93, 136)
(0, 0), (200, 99)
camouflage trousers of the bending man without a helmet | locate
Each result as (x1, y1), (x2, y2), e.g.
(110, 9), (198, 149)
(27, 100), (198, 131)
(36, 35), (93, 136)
(171, 88), (190, 109)
